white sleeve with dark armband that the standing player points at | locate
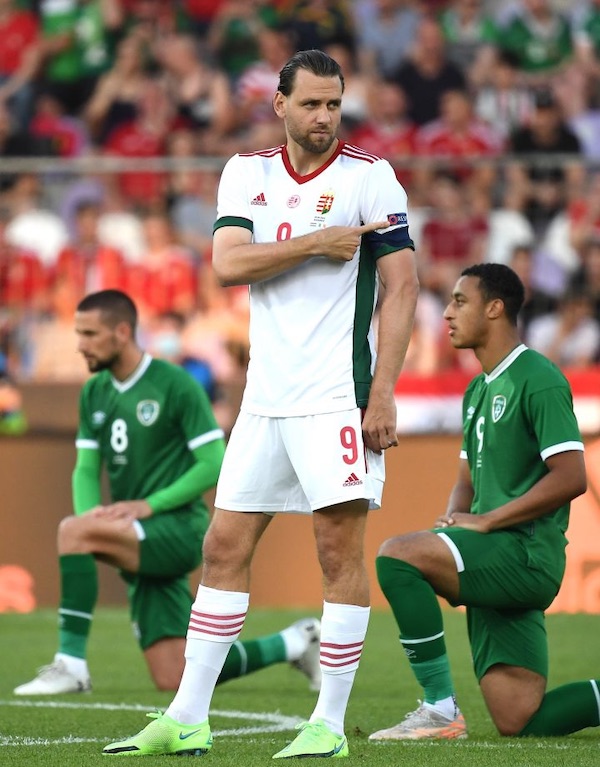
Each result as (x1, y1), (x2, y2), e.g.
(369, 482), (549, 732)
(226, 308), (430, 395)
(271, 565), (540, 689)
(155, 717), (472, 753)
(360, 160), (415, 258)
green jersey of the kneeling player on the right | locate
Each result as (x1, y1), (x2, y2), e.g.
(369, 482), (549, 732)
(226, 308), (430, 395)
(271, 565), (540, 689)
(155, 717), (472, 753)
(461, 345), (583, 564)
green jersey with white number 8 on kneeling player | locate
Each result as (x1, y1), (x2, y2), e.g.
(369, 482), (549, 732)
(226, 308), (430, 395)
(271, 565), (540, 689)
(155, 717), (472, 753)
(76, 354), (223, 514)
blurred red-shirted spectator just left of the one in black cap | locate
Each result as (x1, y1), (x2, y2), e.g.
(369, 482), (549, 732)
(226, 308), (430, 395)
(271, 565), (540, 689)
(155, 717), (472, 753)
(415, 90), (504, 202)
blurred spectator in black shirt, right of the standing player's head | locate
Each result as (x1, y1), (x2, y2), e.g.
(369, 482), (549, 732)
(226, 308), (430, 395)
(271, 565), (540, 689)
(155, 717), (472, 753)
(391, 18), (467, 125)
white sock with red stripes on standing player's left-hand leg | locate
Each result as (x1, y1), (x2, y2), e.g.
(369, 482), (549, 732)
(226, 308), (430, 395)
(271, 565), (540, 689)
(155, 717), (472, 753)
(166, 585), (249, 724)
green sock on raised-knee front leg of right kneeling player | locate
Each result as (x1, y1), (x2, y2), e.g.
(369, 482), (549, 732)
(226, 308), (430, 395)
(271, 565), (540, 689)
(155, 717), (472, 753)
(376, 557), (454, 704)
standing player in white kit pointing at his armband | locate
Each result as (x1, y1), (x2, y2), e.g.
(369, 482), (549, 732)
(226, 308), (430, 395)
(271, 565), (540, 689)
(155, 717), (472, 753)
(104, 50), (418, 758)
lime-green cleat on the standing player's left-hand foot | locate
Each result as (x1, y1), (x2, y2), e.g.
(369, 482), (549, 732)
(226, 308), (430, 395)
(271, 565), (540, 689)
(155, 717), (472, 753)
(102, 713), (212, 756)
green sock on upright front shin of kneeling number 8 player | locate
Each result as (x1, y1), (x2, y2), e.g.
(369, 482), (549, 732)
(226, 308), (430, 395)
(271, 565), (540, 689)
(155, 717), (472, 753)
(58, 554), (98, 658)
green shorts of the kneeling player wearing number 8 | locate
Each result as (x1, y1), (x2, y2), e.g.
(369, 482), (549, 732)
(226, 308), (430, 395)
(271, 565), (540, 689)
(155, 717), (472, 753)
(122, 510), (209, 650)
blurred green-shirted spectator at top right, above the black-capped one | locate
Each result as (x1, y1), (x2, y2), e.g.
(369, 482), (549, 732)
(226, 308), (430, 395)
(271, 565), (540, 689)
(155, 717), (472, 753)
(498, 0), (573, 87)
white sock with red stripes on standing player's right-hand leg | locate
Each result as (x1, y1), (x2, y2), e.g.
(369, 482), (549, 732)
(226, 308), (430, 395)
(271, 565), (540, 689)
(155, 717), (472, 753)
(310, 602), (370, 735)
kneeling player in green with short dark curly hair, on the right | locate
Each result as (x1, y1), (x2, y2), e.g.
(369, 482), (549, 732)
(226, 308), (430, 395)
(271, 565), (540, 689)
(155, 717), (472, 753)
(370, 264), (600, 741)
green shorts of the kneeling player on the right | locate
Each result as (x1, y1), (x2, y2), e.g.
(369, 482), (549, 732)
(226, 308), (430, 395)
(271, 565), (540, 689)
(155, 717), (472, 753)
(435, 528), (558, 680)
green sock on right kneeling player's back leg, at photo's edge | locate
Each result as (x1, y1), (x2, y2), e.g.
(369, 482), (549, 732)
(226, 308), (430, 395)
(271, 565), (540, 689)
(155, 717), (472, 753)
(519, 679), (600, 737)
